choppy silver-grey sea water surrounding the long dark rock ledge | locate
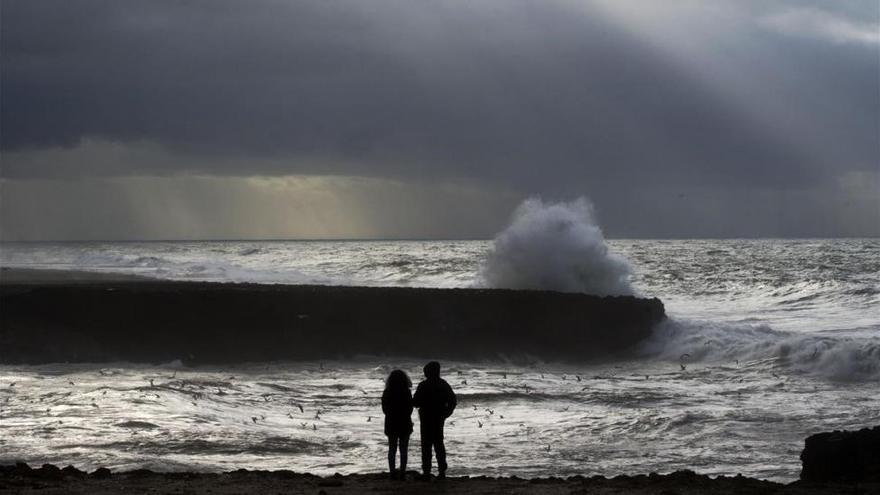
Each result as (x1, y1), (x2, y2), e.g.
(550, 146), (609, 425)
(0, 239), (880, 481)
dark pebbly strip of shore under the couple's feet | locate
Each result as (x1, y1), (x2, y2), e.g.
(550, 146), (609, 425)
(0, 463), (868, 495)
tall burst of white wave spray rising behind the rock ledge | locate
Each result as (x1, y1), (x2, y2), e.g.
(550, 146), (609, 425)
(481, 197), (633, 296)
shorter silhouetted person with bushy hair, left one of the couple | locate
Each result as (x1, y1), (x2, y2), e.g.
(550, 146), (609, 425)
(382, 370), (413, 479)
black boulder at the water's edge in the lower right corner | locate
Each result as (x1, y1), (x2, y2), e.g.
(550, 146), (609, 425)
(801, 426), (880, 482)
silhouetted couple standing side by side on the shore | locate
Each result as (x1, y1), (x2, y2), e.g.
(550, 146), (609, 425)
(382, 361), (456, 480)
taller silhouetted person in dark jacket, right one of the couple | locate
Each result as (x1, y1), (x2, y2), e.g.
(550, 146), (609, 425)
(413, 361), (456, 478)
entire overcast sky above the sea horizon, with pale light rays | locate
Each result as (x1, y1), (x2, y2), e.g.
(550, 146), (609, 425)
(0, 0), (880, 240)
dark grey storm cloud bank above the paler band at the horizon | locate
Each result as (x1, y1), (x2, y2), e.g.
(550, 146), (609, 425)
(0, 0), (880, 193)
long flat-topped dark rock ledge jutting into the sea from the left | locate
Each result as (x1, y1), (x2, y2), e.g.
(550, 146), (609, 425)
(0, 281), (665, 364)
